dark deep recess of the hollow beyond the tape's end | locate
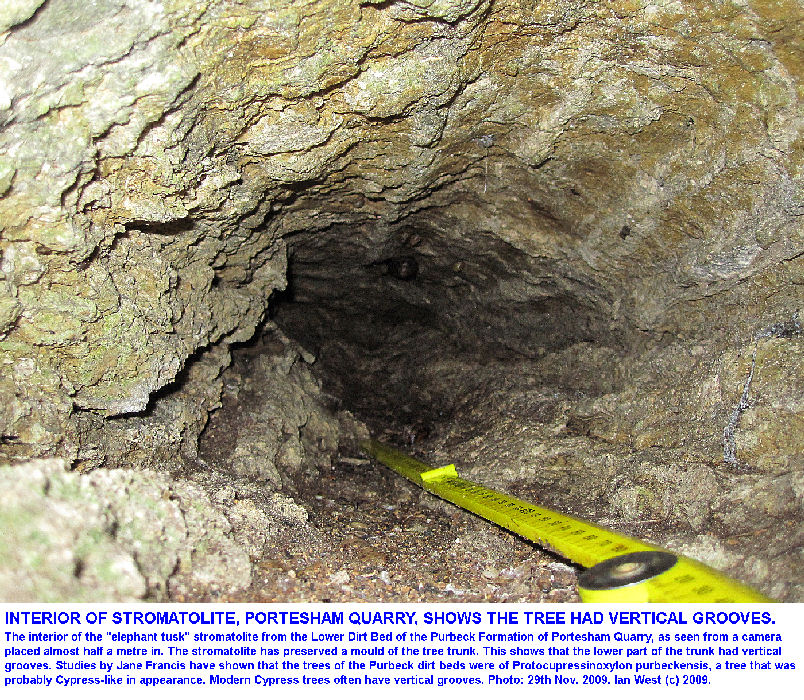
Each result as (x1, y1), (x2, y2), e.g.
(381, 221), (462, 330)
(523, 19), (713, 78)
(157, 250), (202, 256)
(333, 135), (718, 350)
(273, 214), (611, 444)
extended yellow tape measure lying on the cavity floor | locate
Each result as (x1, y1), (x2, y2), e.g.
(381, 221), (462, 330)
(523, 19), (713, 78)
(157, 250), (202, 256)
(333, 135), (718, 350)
(360, 440), (773, 603)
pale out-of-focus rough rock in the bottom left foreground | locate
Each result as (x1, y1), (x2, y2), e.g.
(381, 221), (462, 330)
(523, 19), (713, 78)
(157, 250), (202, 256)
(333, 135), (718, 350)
(0, 459), (256, 602)
